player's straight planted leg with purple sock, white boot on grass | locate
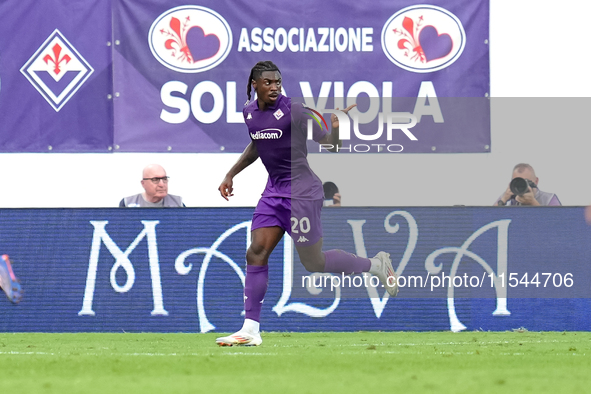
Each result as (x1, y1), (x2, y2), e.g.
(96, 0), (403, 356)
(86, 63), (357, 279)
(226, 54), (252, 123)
(216, 226), (284, 346)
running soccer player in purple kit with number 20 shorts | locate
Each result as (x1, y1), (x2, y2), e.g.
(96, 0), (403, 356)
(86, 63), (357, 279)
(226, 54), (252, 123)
(216, 61), (398, 346)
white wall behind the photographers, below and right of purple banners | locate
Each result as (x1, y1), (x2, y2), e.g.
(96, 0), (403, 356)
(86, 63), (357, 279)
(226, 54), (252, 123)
(0, 0), (591, 208)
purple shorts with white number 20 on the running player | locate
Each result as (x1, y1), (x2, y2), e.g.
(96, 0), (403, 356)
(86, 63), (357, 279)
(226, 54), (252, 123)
(251, 197), (322, 246)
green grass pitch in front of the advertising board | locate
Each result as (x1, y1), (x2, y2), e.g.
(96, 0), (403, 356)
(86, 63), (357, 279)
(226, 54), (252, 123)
(0, 331), (591, 394)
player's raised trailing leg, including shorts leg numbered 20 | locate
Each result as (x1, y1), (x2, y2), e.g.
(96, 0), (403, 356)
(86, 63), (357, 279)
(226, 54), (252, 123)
(291, 200), (398, 296)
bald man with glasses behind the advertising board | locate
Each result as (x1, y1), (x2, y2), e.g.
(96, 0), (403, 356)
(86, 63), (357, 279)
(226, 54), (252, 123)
(119, 164), (185, 208)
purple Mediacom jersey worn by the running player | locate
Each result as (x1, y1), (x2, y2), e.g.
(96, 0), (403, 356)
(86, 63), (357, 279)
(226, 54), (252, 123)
(242, 95), (328, 200)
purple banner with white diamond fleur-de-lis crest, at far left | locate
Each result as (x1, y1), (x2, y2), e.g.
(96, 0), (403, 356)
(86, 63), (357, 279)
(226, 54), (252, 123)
(0, 0), (113, 152)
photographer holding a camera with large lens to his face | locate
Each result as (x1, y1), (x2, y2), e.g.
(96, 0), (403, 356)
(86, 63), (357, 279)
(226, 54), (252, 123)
(494, 163), (562, 206)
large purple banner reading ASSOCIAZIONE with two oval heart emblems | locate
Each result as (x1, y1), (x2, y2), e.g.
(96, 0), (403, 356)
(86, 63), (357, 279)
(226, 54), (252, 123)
(114, 0), (490, 152)
